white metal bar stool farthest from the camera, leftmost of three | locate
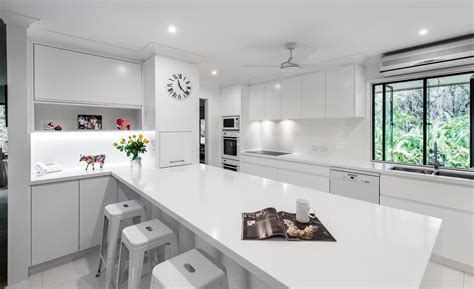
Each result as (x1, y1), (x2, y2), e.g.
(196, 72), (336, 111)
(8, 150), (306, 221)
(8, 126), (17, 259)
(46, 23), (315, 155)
(96, 200), (146, 289)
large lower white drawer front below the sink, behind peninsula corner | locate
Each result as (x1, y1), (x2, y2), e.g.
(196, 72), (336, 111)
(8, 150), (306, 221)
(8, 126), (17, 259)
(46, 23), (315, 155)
(380, 196), (474, 268)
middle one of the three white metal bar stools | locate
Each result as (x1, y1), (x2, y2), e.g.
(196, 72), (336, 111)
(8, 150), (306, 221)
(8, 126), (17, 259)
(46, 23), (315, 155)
(116, 219), (178, 289)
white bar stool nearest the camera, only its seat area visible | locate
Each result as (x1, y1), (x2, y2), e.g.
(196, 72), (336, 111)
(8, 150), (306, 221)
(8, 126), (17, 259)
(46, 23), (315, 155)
(150, 249), (228, 289)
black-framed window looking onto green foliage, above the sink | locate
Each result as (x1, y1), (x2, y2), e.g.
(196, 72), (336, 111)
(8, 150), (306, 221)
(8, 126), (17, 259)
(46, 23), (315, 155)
(372, 72), (474, 169)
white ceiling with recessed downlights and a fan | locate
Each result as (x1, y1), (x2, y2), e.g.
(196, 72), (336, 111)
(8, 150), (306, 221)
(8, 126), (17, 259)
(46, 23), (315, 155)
(0, 0), (474, 85)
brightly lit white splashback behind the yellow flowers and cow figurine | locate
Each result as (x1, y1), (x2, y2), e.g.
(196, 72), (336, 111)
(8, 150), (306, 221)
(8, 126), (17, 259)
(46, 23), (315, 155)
(31, 130), (156, 169)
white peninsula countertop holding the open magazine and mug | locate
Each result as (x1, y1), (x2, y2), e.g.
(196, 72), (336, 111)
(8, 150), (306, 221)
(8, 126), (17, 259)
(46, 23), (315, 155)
(32, 165), (441, 289)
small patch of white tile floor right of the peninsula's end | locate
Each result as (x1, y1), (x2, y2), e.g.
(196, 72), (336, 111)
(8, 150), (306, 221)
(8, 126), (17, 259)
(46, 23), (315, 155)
(420, 261), (469, 289)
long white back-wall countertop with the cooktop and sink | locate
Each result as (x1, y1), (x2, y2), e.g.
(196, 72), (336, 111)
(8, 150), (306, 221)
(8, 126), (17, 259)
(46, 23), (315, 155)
(241, 151), (474, 186)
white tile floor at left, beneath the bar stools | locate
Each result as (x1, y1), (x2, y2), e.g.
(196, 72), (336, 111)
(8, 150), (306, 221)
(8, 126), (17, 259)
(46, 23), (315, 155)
(7, 252), (151, 289)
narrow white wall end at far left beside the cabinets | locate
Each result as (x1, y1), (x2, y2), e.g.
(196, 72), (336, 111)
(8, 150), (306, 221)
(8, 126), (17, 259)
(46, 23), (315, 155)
(0, 11), (32, 284)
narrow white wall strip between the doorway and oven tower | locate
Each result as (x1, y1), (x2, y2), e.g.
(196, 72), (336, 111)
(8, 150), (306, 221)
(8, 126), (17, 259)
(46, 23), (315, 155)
(199, 83), (221, 167)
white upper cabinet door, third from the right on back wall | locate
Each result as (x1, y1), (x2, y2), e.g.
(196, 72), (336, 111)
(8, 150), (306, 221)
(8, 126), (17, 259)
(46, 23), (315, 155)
(281, 76), (302, 119)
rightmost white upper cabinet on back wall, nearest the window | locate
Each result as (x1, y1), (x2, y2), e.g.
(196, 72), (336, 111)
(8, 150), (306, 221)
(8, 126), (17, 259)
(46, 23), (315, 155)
(326, 65), (365, 118)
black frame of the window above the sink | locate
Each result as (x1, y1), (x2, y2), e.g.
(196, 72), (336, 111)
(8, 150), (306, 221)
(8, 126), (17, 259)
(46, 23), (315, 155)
(370, 69), (474, 171)
